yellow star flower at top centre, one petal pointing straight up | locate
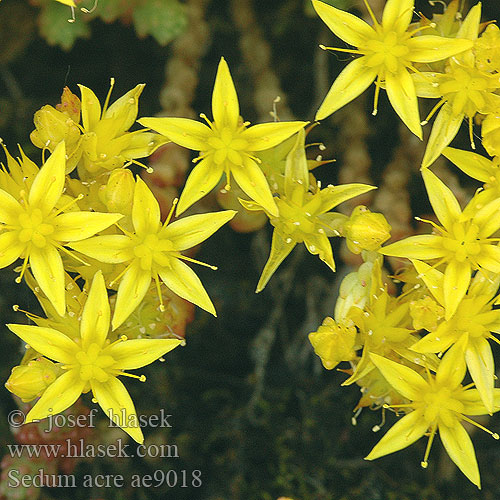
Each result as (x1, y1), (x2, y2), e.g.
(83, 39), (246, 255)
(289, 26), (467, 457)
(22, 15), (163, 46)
(139, 58), (306, 215)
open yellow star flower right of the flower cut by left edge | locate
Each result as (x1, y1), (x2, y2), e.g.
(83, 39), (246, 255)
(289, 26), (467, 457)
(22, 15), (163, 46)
(71, 178), (236, 330)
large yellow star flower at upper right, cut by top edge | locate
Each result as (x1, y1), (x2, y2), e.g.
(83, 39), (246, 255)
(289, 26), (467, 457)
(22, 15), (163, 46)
(312, 0), (472, 139)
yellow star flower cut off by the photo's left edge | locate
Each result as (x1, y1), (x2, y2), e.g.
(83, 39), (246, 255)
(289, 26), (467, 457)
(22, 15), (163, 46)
(0, 142), (123, 316)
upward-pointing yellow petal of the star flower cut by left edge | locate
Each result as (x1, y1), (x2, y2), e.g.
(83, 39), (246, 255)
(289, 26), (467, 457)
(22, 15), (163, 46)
(28, 142), (66, 213)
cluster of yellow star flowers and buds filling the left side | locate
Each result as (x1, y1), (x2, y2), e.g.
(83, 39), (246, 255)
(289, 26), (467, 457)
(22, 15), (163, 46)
(0, 79), (235, 442)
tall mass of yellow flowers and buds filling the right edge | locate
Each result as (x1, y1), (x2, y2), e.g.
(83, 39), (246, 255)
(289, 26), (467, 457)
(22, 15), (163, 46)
(309, 0), (500, 487)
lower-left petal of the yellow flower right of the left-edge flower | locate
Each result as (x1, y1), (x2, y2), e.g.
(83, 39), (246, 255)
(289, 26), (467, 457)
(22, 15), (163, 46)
(112, 262), (151, 330)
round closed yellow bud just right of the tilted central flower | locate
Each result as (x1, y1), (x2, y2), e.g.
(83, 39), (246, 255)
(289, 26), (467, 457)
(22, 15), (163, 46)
(343, 205), (391, 254)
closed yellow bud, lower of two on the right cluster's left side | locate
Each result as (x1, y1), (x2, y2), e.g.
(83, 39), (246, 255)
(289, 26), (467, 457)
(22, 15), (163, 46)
(309, 317), (356, 370)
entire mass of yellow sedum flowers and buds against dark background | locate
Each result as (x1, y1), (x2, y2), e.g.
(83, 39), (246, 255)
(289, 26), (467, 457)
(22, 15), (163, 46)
(4, 0), (500, 488)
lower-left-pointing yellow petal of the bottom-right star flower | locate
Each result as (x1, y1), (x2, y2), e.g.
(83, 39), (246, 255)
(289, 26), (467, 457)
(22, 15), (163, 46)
(365, 410), (429, 460)
